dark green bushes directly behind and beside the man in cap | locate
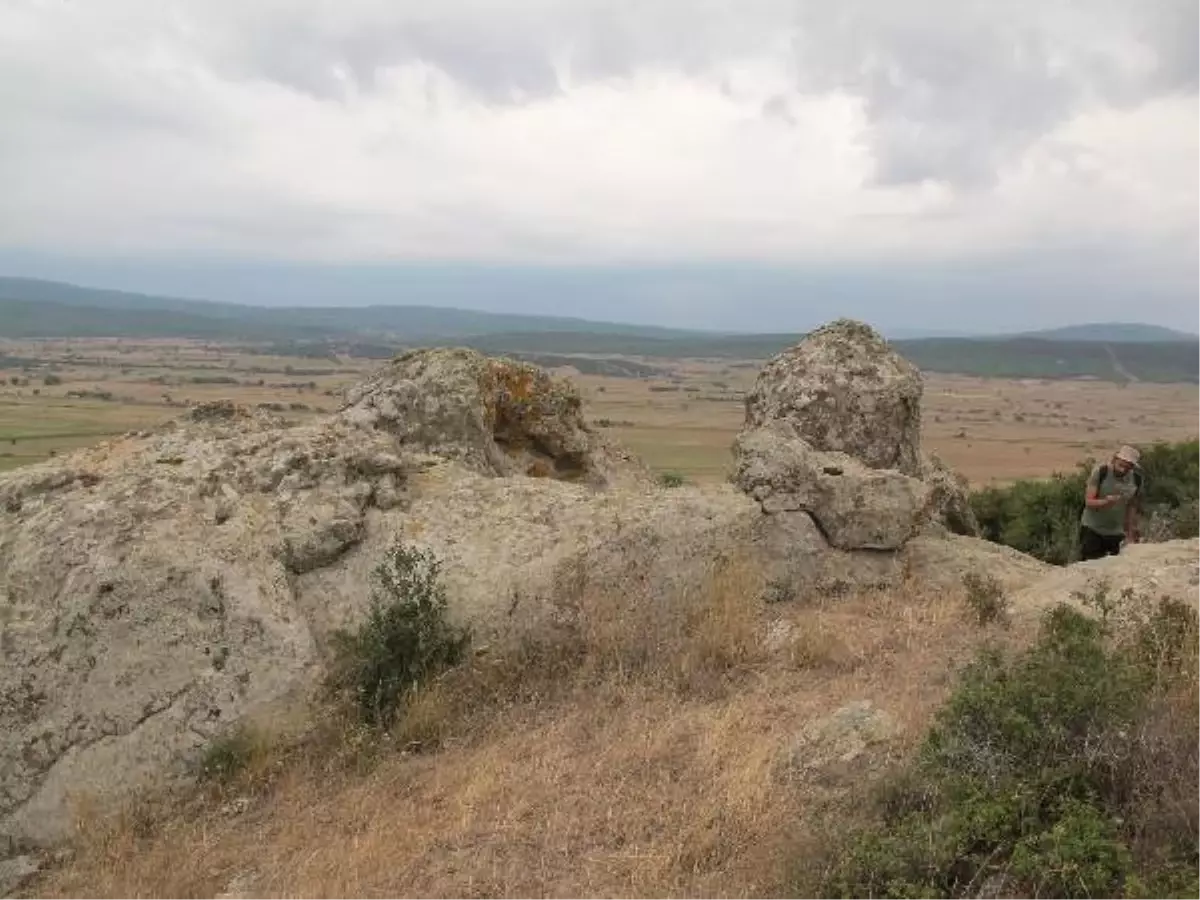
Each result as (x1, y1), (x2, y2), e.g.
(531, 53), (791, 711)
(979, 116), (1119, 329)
(971, 440), (1200, 565)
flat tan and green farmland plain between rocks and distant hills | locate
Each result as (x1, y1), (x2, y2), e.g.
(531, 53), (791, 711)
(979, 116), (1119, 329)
(0, 340), (1200, 485)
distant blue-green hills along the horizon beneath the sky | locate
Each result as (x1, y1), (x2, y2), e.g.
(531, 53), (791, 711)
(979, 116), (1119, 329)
(0, 277), (1200, 382)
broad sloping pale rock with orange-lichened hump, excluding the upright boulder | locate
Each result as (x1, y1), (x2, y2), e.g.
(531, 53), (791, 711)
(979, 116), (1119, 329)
(0, 350), (729, 844)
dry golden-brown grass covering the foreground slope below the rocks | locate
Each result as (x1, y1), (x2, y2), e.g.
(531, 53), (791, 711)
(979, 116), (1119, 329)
(28, 560), (1012, 898)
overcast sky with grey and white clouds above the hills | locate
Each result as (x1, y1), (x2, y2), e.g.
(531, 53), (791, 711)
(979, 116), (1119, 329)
(0, 0), (1200, 330)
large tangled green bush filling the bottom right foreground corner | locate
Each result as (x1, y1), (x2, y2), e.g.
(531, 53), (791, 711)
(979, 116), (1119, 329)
(821, 595), (1200, 898)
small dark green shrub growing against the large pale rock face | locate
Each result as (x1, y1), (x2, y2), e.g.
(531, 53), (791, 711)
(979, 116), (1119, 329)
(330, 542), (470, 727)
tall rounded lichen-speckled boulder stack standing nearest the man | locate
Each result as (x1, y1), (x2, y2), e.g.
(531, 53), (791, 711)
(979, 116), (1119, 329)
(733, 320), (978, 551)
